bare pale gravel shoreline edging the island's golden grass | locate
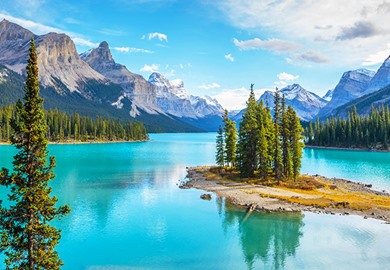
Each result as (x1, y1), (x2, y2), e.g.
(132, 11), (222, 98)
(180, 167), (390, 224)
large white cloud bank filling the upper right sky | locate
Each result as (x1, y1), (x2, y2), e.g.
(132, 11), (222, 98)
(207, 0), (390, 67)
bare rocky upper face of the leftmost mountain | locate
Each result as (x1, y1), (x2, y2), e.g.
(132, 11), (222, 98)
(0, 20), (107, 99)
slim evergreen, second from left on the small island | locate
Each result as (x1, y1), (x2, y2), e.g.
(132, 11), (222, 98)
(223, 110), (237, 167)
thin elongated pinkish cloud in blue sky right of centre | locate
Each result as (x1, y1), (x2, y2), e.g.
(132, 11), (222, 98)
(233, 38), (301, 53)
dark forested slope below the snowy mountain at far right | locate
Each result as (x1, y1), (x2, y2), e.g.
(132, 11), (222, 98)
(334, 85), (390, 118)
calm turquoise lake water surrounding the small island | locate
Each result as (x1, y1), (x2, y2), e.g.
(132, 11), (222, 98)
(0, 134), (390, 270)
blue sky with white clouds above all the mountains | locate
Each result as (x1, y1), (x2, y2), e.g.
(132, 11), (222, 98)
(0, 0), (390, 109)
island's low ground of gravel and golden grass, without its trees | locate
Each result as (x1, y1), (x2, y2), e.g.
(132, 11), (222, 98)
(181, 166), (390, 223)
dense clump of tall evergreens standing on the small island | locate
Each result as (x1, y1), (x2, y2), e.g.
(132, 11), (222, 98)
(217, 84), (304, 183)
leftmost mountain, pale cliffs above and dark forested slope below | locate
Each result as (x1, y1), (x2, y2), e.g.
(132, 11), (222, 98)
(0, 20), (204, 132)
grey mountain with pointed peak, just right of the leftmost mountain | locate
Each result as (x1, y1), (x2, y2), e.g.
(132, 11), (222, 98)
(80, 41), (161, 117)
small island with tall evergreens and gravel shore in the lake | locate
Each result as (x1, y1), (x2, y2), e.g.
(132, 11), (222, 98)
(181, 84), (390, 222)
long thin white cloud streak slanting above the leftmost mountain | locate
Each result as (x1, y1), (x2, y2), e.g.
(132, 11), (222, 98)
(0, 13), (99, 48)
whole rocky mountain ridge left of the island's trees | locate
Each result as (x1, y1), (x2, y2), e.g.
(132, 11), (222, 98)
(0, 20), (223, 132)
